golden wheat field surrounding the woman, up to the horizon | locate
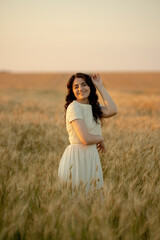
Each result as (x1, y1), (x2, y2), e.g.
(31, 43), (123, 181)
(0, 73), (160, 240)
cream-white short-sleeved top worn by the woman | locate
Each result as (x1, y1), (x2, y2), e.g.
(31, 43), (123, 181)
(66, 100), (101, 144)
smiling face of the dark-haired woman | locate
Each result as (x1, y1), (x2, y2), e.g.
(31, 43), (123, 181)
(72, 78), (90, 101)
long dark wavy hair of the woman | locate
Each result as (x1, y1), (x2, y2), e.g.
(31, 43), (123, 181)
(64, 73), (103, 123)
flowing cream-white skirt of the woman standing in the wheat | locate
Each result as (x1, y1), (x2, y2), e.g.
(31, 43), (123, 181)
(58, 144), (103, 192)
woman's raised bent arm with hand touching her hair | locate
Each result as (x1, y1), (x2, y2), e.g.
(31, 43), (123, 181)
(91, 73), (118, 118)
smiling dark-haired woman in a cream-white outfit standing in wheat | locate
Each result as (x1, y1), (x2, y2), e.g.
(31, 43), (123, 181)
(58, 73), (118, 196)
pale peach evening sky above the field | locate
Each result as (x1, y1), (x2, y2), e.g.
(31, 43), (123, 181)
(0, 0), (160, 72)
